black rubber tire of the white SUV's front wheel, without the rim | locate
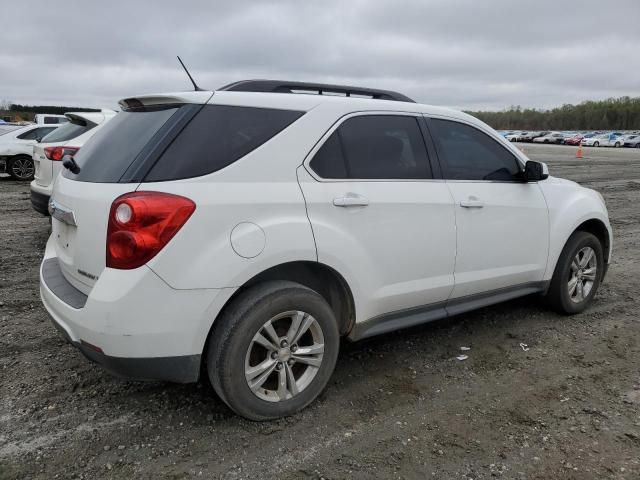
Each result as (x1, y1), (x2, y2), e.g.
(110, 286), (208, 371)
(554, 232), (604, 313)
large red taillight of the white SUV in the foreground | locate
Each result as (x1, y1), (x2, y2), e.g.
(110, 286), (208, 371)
(107, 192), (196, 270)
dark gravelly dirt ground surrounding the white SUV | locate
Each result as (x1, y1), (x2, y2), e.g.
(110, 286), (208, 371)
(0, 145), (640, 480)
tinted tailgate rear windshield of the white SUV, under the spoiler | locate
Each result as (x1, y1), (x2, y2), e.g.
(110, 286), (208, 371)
(64, 107), (178, 183)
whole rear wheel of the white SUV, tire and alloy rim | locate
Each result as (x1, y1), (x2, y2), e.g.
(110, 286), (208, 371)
(207, 281), (340, 421)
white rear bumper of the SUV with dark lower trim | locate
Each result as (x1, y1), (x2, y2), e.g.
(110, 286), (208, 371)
(40, 239), (235, 383)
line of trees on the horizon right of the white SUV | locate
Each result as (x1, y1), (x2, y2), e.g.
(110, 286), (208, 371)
(467, 97), (640, 130)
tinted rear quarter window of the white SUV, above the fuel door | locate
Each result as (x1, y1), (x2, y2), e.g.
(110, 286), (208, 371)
(145, 105), (303, 182)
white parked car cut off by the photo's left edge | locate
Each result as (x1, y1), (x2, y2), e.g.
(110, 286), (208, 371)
(0, 125), (60, 180)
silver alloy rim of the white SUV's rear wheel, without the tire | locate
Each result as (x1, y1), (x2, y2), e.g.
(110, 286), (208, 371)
(245, 310), (324, 402)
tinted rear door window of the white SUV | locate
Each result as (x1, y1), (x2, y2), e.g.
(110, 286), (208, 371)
(311, 115), (431, 180)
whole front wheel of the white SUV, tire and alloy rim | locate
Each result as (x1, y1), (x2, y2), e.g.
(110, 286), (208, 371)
(547, 231), (604, 315)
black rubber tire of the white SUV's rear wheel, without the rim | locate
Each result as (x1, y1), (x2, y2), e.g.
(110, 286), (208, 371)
(210, 286), (340, 420)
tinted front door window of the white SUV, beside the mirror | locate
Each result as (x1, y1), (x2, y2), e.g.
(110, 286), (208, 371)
(430, 119), (521, 181)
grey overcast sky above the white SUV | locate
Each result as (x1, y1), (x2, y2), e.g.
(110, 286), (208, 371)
(0, 0), (640, 110)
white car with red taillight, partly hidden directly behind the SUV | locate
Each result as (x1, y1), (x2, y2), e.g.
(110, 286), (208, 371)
(31, 110), (116, 215)
